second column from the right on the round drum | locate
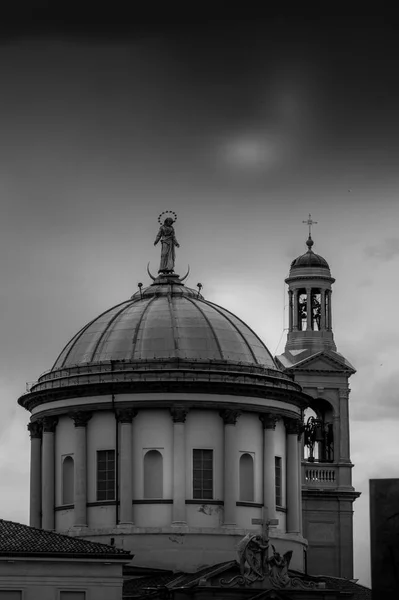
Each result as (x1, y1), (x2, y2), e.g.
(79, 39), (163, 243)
(259, 413), (278, 520)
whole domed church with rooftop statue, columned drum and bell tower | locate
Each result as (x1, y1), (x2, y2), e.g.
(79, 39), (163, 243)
(19, 219), (358, 578)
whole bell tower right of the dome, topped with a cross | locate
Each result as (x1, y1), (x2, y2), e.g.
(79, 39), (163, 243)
(276, 215), (360, 579)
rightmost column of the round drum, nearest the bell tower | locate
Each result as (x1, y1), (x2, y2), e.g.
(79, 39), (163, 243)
(285, 419), (301, 533)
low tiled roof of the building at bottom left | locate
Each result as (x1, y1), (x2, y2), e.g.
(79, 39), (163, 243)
(0, 519), (132, 560)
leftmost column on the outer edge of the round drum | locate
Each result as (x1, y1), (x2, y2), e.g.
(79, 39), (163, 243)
(28, 421), (42, 529)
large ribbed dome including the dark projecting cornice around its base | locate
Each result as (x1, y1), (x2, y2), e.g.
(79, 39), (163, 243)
(18, 274), (302, 410)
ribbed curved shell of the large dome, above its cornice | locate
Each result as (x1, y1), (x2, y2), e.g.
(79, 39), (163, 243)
(51, 282), (278, 371)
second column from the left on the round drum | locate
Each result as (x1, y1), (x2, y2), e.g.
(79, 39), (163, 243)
(42, 417), (58, 530)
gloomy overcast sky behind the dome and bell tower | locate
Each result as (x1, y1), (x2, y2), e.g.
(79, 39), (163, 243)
(0, 20), (399, 585)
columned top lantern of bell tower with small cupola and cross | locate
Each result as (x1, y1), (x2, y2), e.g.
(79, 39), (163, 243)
(285, 215), (336, 351)
